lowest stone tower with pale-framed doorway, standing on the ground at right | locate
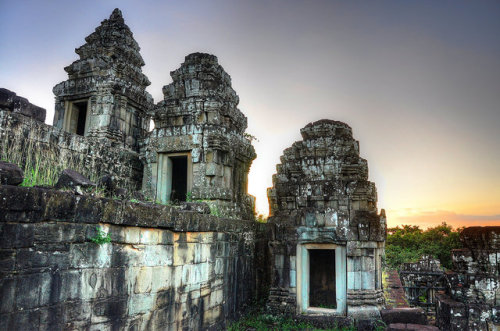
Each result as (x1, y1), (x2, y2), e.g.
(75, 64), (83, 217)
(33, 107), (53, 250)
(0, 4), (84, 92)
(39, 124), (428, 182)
(268, 120), (386, 317)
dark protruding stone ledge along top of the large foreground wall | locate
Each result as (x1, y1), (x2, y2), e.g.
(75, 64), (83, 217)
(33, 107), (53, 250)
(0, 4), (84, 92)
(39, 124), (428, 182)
(0, 185), (257, 233)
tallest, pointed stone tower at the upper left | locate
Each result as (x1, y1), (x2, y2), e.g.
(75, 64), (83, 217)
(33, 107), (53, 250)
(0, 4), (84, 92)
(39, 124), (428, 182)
(53, 9), (153, 150)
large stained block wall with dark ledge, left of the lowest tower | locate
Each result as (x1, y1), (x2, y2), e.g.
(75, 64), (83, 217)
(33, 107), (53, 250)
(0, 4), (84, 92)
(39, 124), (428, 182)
(0, 186), (258, 330)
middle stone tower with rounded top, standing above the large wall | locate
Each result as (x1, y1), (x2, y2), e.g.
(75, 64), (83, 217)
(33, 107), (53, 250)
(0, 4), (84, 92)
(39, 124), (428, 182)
(141, 53), (256, 219)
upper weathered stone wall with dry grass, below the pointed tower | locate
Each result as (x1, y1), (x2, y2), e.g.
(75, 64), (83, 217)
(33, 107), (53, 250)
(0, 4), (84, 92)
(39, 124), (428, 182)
(0, 110), (142, 190)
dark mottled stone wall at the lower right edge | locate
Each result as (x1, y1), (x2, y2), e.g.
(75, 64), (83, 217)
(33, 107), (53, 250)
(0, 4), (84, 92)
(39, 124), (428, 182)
(436, 227), (500, 330)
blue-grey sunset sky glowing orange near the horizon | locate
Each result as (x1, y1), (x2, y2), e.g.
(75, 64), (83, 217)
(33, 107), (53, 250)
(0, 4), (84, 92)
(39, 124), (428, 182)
(0, 0), (500, 228)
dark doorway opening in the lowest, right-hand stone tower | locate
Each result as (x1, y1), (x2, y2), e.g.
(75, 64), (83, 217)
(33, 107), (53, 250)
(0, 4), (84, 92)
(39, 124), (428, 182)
(309, 249), (337, 309)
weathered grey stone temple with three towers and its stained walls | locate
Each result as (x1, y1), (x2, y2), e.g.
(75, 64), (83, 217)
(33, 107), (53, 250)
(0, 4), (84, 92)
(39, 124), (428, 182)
(0, 9), (398, 330)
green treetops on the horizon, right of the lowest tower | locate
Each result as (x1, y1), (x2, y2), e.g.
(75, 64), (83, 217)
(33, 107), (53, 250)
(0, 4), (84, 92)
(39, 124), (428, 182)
(385, 222), (462, 269)
